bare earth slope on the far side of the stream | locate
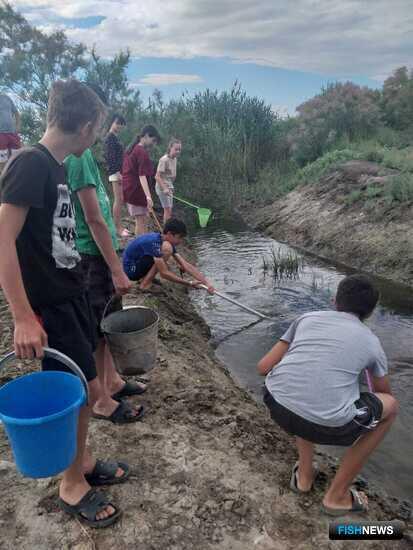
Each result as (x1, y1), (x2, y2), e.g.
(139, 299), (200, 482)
(246, 161), (413, 285)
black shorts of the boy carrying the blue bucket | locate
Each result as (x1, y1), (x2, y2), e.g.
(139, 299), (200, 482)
(36, 295), (97, 382)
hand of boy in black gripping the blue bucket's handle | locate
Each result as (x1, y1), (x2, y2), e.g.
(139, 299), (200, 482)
(14, 316), (47, 359)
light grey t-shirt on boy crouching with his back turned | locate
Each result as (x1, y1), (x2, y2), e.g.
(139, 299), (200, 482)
(265, 311), (387, 426)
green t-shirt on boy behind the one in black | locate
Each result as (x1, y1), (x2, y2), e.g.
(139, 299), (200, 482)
(65, 149), (119, 256)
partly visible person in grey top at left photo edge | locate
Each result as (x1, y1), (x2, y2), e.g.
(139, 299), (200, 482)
(0, 93), (21, 174)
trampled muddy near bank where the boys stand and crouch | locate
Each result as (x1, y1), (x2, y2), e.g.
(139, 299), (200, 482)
(0, 285), (413, 550)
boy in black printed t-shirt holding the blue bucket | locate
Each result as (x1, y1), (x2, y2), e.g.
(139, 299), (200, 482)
(0, 80), (130, 527)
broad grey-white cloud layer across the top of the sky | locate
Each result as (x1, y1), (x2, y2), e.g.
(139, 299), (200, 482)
(14, 0), (413, 77)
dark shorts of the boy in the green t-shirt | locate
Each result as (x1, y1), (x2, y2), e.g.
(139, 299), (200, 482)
(80, 254), (122, 338)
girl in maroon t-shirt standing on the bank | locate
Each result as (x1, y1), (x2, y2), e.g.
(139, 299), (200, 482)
(122, 125), (161, 235)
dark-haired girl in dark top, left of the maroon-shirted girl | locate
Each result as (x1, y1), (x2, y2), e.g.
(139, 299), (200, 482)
(104, 113), (130, 237)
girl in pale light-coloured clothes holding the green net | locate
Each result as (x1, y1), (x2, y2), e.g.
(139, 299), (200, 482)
(155, 138), (182, 224)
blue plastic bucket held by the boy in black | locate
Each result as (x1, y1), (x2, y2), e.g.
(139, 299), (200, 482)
(0, 371), (86, 478)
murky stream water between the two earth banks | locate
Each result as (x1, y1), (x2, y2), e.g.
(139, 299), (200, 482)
(192, 220), (413, 500)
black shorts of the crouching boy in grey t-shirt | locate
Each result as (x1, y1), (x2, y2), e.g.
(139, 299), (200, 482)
(264, 388), (383, 447)
